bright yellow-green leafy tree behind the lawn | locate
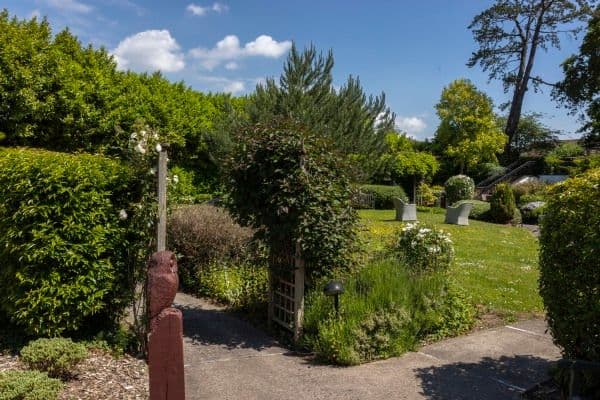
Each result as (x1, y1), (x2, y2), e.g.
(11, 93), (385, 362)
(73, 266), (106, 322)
(434, 79), (506, 173)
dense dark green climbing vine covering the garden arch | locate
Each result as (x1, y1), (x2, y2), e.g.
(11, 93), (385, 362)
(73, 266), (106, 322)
(228, 122), (357, 274)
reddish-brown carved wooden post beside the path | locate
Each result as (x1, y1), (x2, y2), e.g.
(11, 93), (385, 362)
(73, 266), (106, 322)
(147, 251), (185, 400)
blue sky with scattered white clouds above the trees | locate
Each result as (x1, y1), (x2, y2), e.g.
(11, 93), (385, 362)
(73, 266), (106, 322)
(0, 0), (581, 139)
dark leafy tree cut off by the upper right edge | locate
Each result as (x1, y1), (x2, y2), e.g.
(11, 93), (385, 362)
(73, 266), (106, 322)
(553, 6), (600, 148)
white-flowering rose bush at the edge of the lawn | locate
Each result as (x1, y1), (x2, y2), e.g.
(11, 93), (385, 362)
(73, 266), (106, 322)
(392, 222), (454, 273)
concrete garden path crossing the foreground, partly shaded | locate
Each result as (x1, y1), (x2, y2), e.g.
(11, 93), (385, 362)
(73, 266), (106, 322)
(175, 294), (560, 400)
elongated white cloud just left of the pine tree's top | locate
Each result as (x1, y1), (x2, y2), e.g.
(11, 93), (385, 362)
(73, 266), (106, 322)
(189, 35), (292, 70)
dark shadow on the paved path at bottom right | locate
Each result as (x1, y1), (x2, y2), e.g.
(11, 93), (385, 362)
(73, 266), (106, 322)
(415, 355), (552, 400)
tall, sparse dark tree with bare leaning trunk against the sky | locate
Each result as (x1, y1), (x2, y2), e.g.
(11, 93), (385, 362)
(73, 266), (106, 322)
(467, 0), (595, 154)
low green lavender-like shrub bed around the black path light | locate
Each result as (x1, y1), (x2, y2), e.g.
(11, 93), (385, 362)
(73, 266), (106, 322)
(303, 258), (474, 365)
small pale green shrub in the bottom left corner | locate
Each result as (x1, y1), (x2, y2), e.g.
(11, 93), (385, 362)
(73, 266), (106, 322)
(0, 371), (64, 400)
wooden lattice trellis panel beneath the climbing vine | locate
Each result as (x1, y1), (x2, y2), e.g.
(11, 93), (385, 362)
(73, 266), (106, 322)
(269, 243), (304, 341)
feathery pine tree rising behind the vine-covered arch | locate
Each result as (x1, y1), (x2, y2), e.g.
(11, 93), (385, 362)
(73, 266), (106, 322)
(248, 45), (394, 179)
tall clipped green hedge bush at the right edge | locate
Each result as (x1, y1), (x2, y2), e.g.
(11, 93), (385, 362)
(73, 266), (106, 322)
(540, 168), (600, 362)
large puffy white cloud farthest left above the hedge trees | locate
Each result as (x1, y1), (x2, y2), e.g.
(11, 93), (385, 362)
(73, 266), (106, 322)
(111, 30), (185, 72)
